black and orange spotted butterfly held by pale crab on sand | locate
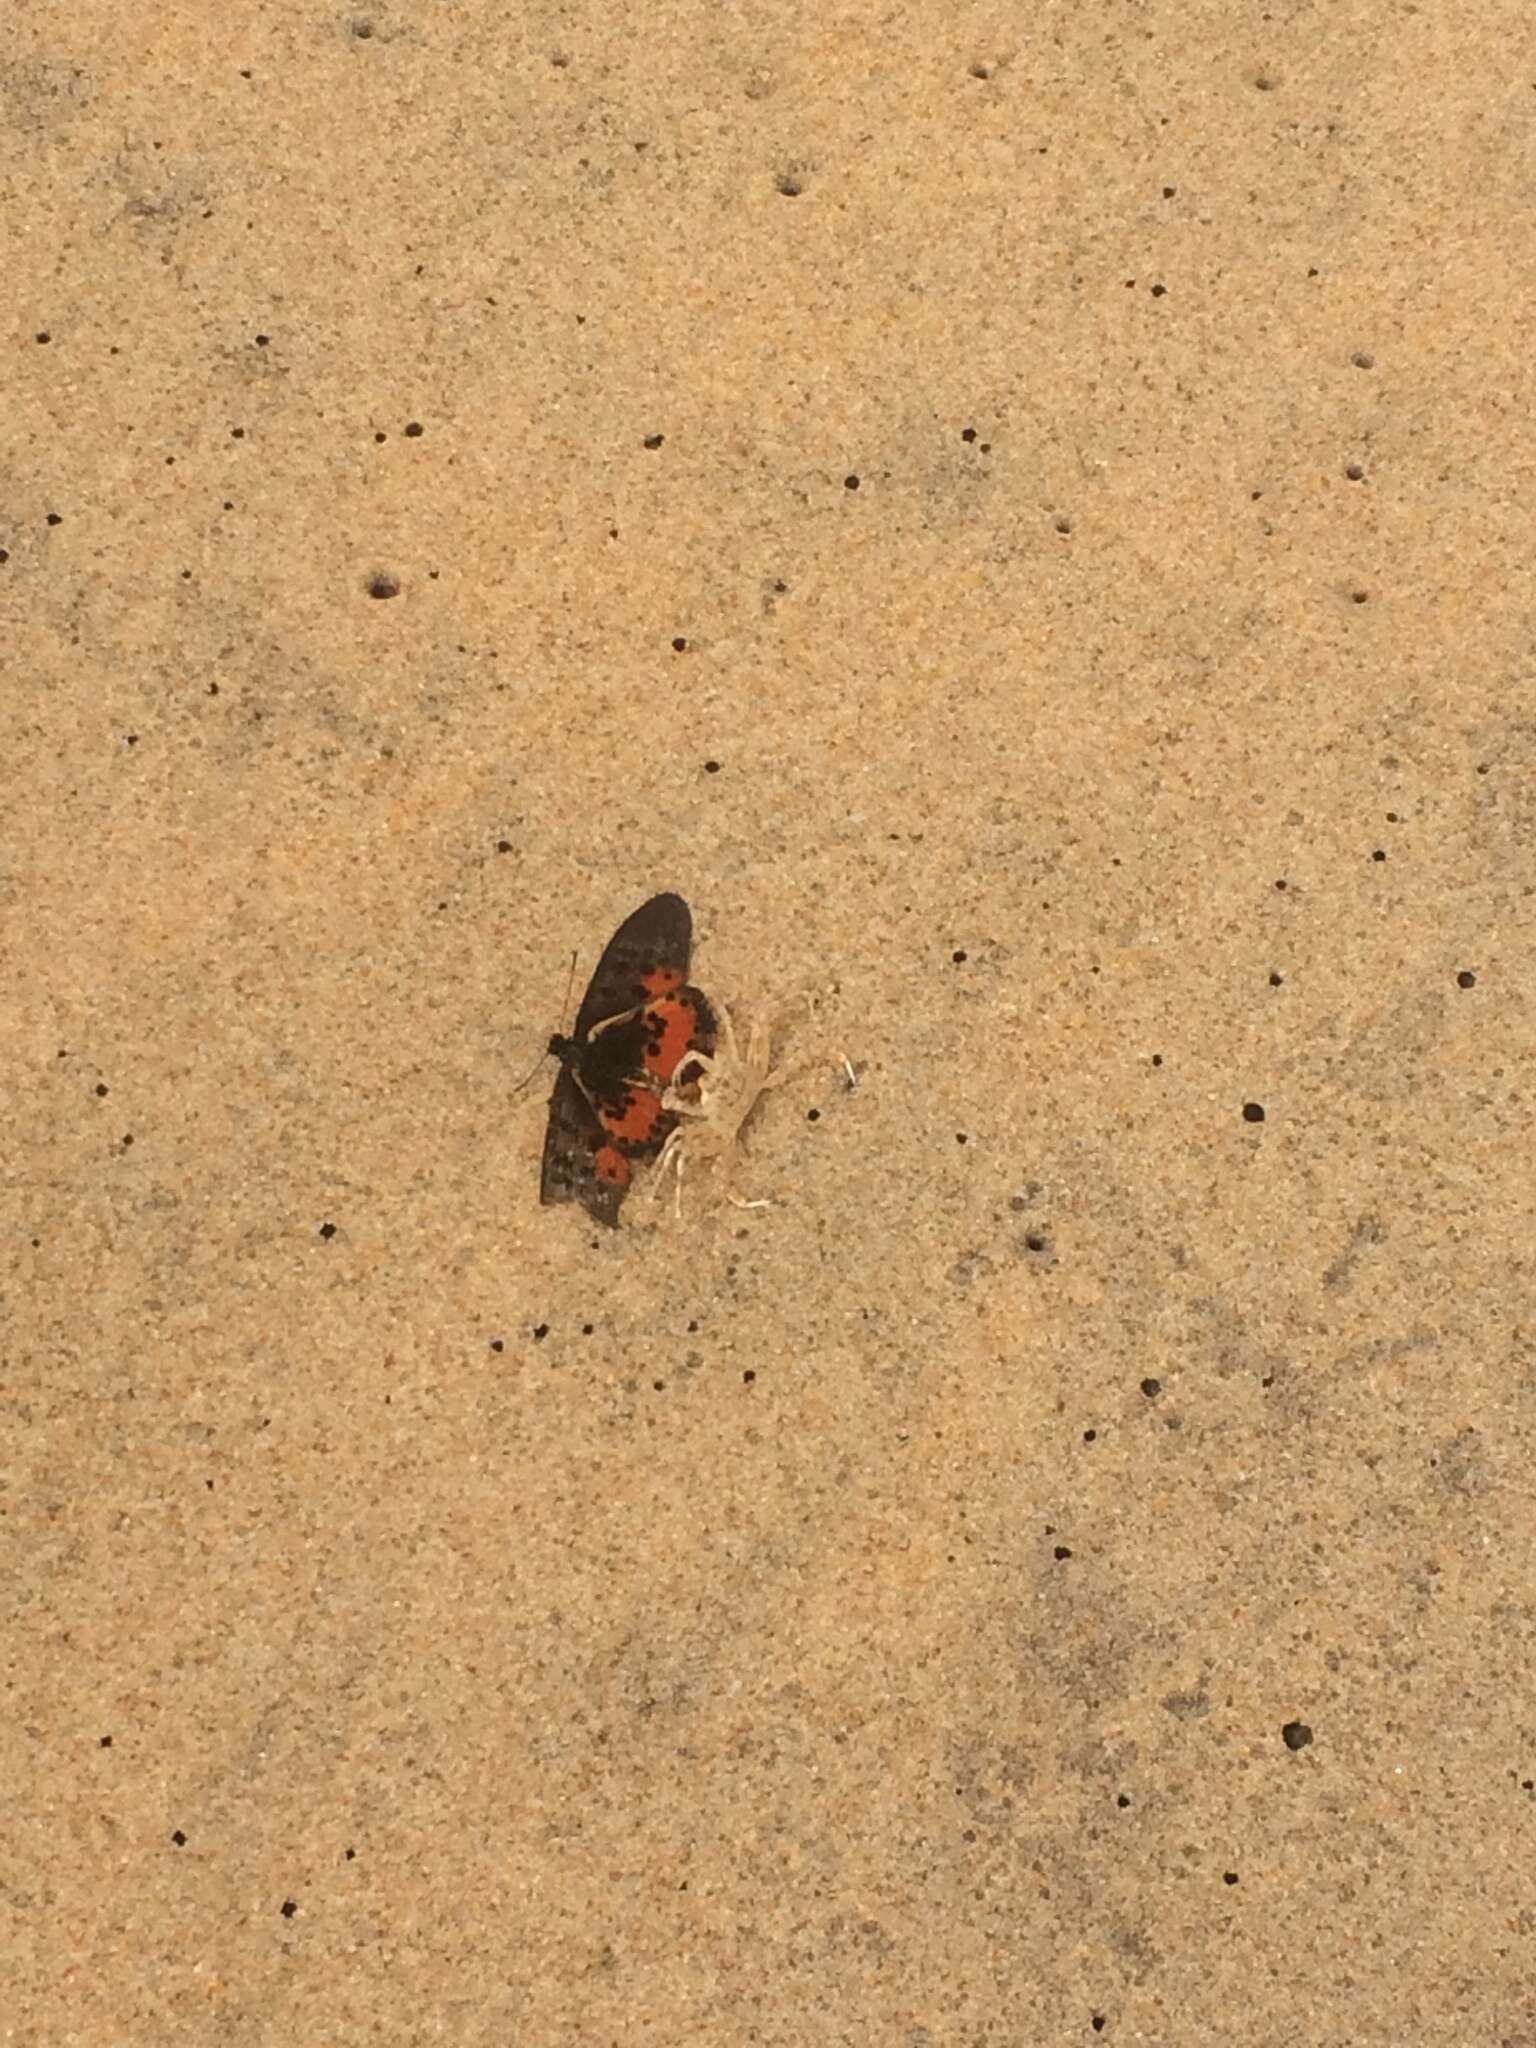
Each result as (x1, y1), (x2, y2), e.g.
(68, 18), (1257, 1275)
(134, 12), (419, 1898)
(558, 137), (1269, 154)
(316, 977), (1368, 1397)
(539, 895), (715, 1227)
